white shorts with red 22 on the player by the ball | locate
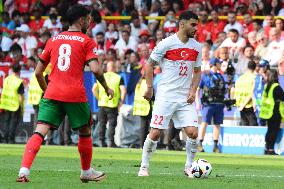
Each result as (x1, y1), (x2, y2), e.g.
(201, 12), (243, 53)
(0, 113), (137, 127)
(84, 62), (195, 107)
(150, 100), (198, 129)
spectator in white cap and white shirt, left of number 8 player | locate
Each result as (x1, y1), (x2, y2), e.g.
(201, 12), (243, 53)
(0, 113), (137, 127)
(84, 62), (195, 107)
(16, 24), (37, 58)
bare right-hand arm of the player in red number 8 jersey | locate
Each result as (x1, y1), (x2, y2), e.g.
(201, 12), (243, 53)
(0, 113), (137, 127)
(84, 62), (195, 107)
(88, 59), (113, 99)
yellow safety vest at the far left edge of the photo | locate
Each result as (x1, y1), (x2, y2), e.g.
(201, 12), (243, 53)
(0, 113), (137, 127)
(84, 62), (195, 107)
(0, 74), (23, 112)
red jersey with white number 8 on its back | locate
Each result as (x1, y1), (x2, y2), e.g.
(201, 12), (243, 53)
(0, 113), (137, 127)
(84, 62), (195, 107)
(40, 31), (97, 102)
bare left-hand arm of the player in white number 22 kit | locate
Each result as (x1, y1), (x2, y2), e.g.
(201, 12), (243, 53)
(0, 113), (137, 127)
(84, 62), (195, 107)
(144, 57), (158, 101)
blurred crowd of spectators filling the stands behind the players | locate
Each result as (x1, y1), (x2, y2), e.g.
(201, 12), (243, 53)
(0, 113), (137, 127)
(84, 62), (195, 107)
(0, 0), (284, 149)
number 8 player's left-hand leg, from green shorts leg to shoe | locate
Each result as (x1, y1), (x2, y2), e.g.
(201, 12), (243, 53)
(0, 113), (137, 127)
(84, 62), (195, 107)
(17, 99), (65, 182)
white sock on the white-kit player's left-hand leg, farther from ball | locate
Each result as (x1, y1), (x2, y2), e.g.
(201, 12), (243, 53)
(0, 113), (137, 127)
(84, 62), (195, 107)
(141, 135), (158, 168)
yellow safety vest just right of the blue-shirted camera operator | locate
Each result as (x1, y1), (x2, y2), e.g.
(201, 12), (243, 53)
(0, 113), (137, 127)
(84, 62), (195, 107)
(235, 73), (255, 108)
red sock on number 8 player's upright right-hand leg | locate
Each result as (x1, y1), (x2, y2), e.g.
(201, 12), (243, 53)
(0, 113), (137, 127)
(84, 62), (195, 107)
(78, 136), (93, 170)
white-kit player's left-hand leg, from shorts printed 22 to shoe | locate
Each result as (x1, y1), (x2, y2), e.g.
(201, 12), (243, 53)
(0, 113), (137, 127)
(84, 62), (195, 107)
(138, 101), (174, 176)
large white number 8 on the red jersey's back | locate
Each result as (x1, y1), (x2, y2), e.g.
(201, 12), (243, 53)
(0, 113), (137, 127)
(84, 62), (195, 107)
(57, 44), (71, 72)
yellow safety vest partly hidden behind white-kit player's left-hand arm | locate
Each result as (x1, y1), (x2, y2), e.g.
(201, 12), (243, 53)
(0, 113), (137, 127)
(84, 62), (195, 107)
(133, 79), (150, 116)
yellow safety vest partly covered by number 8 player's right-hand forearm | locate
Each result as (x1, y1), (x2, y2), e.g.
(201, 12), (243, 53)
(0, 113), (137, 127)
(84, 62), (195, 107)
(98, 72), (121, 108)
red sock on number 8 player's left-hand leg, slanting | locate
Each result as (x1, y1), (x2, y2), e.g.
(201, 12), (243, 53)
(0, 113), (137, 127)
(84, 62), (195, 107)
(21, 133), (43, 169)
